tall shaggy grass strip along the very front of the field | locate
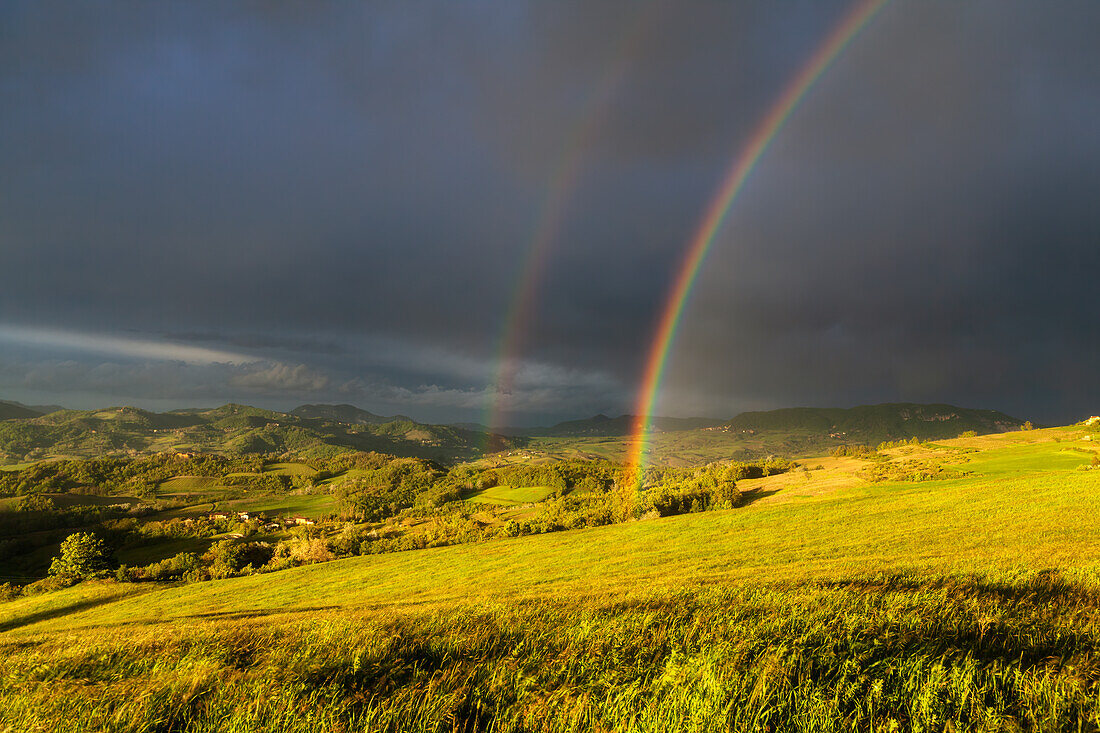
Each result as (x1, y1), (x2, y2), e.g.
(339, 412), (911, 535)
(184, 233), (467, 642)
(0, 571), (1100, 733)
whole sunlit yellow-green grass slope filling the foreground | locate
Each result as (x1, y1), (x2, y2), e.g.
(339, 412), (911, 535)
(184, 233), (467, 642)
(0, 430), (1100, 731)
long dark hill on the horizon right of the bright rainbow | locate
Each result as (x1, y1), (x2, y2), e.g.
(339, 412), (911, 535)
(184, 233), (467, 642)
(726, 403), (1023, 442)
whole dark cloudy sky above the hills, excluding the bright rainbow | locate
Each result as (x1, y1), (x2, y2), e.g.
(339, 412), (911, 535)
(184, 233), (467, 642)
(0, 0), (1100, 424)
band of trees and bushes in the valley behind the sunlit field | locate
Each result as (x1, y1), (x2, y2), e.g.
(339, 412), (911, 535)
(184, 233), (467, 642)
(0, 444), (794, 592)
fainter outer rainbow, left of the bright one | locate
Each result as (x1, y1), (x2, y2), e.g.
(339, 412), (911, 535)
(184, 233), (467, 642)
(485, 0), (663, 440)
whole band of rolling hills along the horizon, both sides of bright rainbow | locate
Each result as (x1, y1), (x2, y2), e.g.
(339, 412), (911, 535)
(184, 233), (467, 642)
(0, 394), (1022, 466)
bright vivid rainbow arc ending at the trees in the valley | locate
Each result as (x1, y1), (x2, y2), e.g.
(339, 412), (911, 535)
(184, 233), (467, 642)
(627, 0), (889, 489)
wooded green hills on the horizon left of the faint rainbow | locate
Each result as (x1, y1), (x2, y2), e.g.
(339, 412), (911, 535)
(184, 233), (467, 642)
(0, 404), (524, 462)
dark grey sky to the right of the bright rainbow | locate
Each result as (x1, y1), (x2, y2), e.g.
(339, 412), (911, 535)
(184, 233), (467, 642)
(655, 3), (1100, 420)
